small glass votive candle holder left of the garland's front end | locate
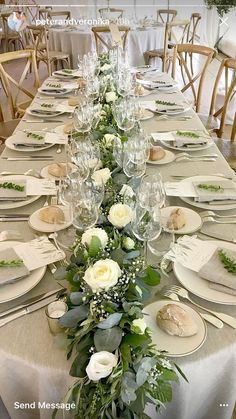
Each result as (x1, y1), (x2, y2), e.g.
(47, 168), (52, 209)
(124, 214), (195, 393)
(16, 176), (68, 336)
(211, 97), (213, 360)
(45, 300), (68, 335)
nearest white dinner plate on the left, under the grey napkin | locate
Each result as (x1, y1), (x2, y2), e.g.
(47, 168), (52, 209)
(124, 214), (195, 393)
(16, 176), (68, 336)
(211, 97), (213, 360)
(0, 241), (46, 303)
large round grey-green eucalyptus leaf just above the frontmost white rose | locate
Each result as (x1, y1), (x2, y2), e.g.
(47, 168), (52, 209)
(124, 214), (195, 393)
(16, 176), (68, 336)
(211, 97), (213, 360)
(94, 326), (123, 352)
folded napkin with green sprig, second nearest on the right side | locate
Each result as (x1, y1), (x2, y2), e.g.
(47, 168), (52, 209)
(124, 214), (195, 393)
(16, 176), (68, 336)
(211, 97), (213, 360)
(193, 179), (236, 202)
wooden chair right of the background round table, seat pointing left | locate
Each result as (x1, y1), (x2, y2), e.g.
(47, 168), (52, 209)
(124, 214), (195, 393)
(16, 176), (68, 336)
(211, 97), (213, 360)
(144, 20), (189, 71)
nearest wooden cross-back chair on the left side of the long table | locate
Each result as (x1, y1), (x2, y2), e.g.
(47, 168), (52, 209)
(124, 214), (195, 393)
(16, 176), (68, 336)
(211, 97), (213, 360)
(0, 50), (39, 119)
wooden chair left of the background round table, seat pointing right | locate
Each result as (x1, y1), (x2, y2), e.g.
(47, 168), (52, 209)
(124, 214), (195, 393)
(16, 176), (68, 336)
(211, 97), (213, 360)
(28, 25), (70, 75)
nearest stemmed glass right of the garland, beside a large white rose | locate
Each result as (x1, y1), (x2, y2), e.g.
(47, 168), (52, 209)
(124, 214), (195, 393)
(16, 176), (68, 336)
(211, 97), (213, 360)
(131, 202), (161, 266)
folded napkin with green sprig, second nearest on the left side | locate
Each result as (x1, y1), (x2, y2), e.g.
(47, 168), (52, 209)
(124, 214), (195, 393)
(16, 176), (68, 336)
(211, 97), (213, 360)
(0, 178), (27, 201)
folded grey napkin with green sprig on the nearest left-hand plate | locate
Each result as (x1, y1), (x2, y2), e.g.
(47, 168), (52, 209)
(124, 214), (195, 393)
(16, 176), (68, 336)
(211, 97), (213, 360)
(0, 248), (29, 286)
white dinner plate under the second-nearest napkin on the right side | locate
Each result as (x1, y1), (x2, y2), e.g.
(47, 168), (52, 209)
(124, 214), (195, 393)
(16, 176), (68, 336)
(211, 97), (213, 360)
(180, 176), (236, 211)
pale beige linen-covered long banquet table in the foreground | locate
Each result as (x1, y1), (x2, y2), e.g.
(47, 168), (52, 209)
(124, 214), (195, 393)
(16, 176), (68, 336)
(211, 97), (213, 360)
(0, 73), (236, 419)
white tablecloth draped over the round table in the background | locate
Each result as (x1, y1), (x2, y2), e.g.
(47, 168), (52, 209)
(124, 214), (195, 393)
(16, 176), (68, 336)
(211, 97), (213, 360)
(49, 26), (164, 68)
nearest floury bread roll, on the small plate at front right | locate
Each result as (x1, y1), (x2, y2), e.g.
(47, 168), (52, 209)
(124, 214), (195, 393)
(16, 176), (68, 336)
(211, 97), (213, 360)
(156, 304), (198, 337)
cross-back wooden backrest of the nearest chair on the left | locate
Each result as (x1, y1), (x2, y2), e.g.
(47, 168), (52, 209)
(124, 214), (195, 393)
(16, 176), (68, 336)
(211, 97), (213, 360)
(0, 50), (39, 119)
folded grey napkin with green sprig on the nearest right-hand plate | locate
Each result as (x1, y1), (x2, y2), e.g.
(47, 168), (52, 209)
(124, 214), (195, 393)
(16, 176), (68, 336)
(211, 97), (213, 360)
(198, 248), (236, 291)
